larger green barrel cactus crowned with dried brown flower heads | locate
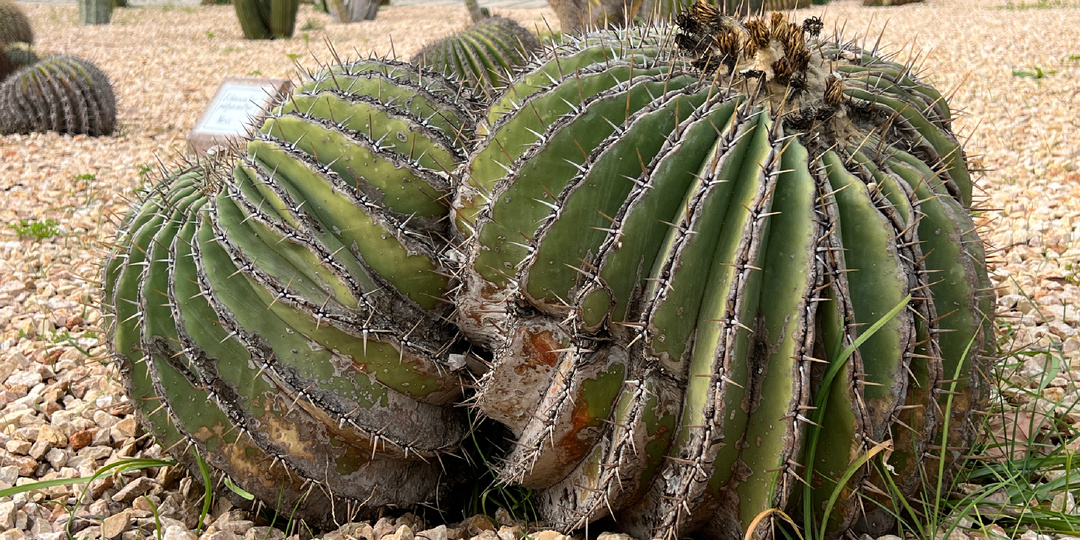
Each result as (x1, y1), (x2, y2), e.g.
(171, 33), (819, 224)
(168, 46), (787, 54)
(455, 9), (990, 537)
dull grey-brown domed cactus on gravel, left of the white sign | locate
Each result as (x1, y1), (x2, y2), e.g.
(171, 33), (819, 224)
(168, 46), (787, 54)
(0, 55), (117, 136)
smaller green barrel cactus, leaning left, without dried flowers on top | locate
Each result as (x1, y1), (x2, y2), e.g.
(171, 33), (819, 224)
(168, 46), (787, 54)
(105, 59), (475, 524)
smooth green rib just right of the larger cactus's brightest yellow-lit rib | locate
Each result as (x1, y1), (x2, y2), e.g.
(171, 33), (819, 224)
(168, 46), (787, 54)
(738, 133), (822, 530)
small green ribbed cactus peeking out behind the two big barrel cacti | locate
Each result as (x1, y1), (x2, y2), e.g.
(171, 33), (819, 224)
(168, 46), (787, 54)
(411, 17), (540, 96)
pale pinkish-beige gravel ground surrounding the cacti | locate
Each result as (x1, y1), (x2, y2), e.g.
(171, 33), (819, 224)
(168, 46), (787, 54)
(0, 0), (1080, 540)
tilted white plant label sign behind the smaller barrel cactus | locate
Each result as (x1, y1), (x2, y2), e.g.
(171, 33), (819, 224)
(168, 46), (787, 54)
(188, 77), (292, 156)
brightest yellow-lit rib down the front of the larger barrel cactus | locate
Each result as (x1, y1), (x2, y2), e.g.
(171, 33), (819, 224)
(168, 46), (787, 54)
(639, 111), (775, 536)
